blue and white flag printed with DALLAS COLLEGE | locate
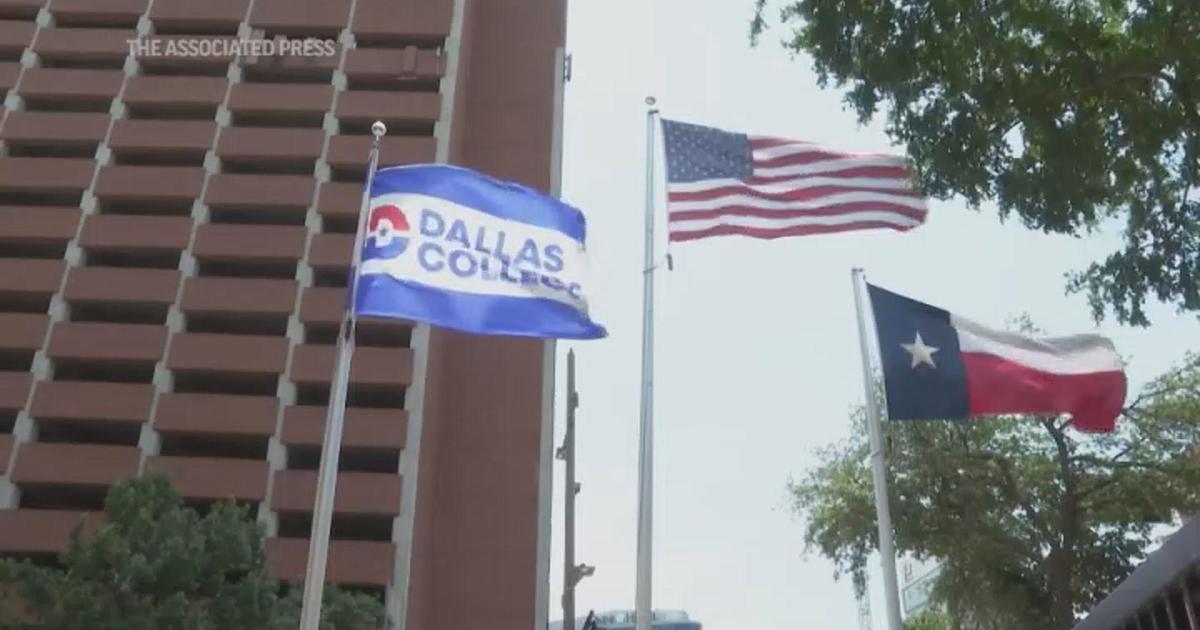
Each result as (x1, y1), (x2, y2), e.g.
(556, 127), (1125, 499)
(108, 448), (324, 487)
(355, 164), (606, 338)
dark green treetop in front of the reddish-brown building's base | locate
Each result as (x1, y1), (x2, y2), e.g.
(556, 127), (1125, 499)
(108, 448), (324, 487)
(0, 475), (384, 630)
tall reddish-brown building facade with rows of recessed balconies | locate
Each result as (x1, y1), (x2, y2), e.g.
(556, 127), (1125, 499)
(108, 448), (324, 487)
(0, 0), (565, 630)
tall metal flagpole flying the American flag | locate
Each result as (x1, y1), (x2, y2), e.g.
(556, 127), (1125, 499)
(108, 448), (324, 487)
(634, 96), (659, 630)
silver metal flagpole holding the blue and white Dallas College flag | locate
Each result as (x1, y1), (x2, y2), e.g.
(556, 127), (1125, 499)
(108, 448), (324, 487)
(300, 120), (388, 630)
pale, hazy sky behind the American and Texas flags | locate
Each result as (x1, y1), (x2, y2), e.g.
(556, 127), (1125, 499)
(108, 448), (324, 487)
(550, 0), (1200, 630)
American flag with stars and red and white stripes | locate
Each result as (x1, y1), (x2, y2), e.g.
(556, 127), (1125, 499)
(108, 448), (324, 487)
(662, 120), (926, 241)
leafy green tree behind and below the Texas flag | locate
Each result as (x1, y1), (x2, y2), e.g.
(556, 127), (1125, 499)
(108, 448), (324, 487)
(791, 356), (1200, 630)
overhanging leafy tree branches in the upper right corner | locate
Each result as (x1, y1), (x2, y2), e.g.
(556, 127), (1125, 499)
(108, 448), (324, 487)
(751, 0), (1200, 325)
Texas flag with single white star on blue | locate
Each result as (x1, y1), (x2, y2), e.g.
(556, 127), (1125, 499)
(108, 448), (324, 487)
(868, 284), (1126, 431)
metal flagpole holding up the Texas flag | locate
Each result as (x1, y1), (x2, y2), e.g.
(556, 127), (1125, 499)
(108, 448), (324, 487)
(850, 268), (902, 630)
